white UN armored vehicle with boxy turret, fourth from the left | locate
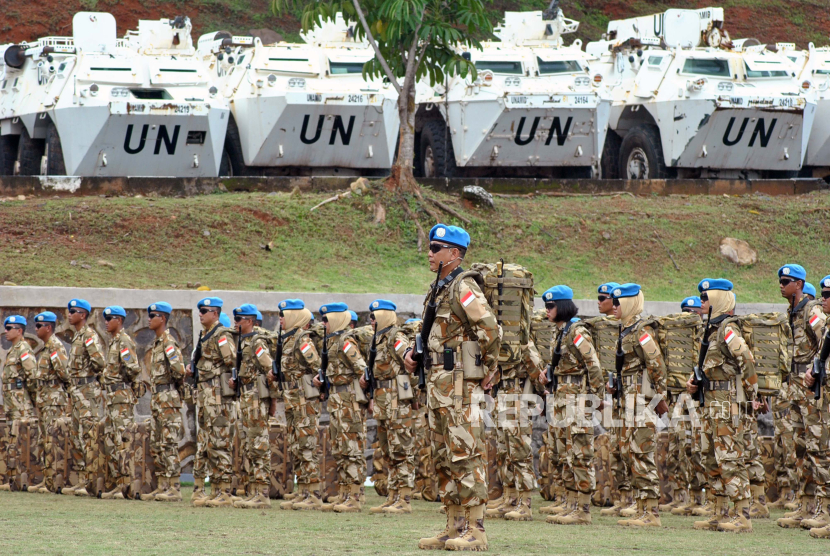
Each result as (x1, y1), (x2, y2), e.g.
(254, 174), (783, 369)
(586, 8), (816, 179)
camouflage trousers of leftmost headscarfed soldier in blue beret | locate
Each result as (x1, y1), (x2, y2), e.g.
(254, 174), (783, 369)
(285, 399), (320, 484)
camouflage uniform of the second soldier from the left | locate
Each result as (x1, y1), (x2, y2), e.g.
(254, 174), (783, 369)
(34, 335), (69, 492)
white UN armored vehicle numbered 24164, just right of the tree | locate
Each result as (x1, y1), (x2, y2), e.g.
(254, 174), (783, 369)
(415, 7), (610, 177)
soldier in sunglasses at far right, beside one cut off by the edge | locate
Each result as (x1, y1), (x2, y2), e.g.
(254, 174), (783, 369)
(778, 264), (830, 528)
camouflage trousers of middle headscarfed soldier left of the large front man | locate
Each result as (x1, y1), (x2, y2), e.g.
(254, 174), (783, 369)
(327, 392), (366, 485)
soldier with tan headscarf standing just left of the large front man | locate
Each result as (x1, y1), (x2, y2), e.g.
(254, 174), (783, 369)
(361, 299), (415, 514)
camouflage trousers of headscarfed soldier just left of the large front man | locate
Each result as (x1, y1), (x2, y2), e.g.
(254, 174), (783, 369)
(377, 402), (415, 490)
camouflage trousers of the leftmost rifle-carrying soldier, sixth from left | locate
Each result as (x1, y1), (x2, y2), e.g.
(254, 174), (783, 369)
(193, 378), (236, 483)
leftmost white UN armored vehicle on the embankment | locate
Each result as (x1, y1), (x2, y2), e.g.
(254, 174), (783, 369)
(0, 12), (228, 177)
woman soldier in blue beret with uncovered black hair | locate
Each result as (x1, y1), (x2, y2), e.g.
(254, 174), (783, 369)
(541, 286), (605, 525)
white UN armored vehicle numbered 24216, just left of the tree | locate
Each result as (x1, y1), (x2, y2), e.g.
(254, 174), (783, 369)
(199, 14), (400, 175)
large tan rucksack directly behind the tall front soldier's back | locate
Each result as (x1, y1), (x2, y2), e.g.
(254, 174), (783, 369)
(470, 262), (535, 369)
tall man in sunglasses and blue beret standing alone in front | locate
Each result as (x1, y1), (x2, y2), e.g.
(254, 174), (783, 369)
(405, 224), (501, 550)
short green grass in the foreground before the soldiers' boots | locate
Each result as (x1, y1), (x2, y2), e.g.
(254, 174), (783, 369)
(0, 488), (830, 556)
